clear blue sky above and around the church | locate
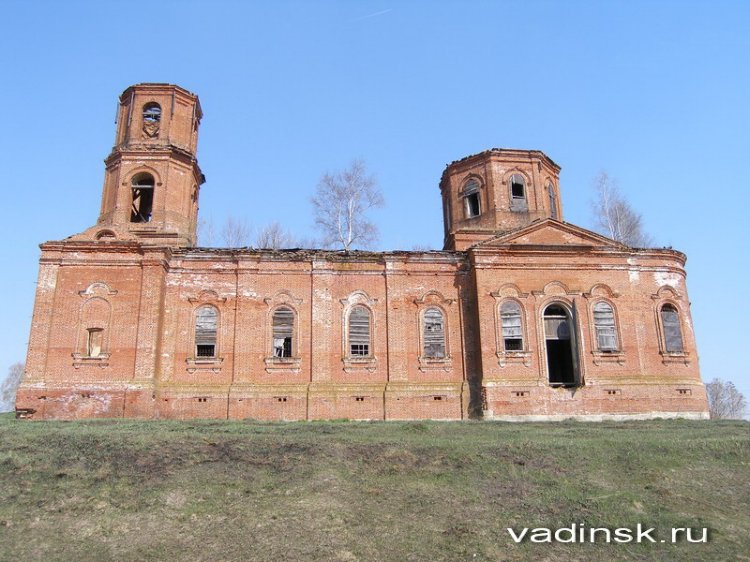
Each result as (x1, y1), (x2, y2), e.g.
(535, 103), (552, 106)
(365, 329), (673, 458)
(0, 0), (750, 398)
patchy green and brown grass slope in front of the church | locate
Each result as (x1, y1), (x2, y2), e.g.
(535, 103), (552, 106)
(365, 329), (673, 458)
(0, 415), (750, 562)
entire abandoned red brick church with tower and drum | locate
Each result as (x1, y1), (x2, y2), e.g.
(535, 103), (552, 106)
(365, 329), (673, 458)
(16, 84), (707, 420)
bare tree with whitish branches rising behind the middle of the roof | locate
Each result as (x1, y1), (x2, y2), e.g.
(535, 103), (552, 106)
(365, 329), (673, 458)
(311, 160), (383, 251)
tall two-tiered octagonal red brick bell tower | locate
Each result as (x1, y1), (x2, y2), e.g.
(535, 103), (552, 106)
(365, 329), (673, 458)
(94, 84), (205, 246)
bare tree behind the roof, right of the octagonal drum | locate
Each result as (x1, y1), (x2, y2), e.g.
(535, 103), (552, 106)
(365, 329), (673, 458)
(593, 171), (653, 248)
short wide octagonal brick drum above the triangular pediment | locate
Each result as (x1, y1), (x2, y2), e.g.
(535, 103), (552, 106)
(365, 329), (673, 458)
(440, 148), (562, 250)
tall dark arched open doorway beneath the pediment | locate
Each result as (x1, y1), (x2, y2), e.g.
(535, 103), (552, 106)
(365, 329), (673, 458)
(544, 304), (579, 386)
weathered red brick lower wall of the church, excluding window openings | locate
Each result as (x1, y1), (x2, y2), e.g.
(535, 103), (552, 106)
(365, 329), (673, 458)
(18, 242), (705, 420)
